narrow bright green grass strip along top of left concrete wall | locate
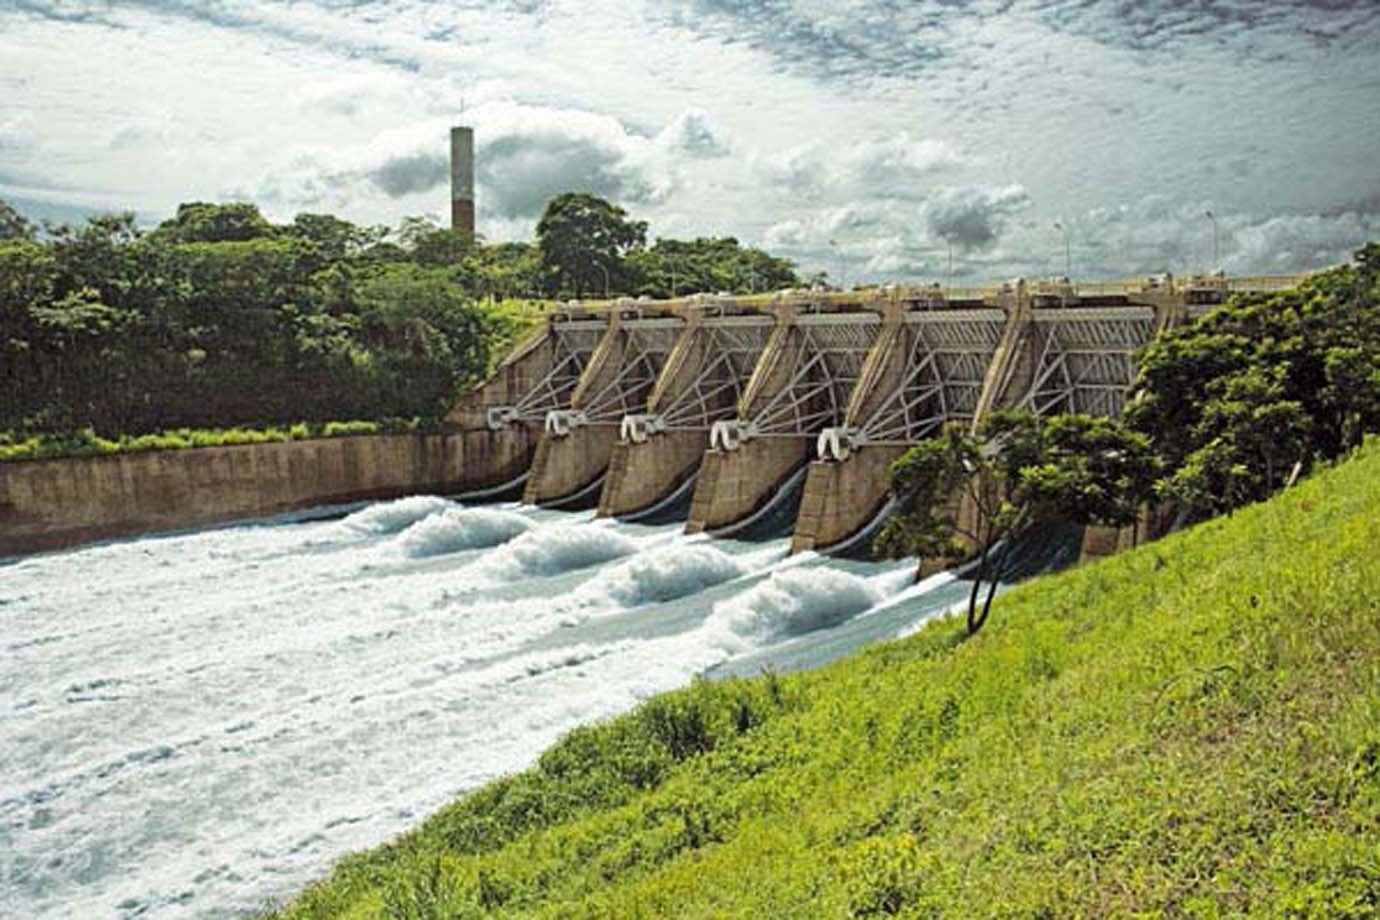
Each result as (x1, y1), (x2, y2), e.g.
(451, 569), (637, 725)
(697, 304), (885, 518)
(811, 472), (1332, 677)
(0, 419), (426, 462)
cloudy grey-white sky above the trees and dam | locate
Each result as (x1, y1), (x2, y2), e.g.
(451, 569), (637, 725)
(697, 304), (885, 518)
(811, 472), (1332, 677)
(0, 0), (1380, 281)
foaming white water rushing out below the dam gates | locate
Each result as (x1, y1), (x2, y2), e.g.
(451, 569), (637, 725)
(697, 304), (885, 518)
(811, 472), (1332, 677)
(0, 497), (962, 917)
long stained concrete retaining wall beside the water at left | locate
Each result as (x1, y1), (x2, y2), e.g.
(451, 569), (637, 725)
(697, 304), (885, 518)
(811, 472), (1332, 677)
(0, 432), (529, 557)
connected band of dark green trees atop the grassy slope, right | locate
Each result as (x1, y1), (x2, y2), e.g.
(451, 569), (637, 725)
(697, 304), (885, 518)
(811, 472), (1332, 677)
(874, 243), (1380, 633)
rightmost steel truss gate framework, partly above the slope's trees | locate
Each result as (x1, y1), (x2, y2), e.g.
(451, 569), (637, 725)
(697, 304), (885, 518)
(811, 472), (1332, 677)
(1018, 306), (1155, 418)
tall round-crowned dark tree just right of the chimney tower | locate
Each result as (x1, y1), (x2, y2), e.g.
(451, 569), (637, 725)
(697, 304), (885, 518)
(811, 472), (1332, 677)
(537, 192), (647, 298)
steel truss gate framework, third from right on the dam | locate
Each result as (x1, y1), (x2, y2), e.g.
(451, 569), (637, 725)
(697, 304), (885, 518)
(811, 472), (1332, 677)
(740, 313), (880, 437)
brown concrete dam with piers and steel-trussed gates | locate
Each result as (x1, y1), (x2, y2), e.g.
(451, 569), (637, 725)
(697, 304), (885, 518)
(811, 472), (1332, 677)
(446, 274), (1300, 550)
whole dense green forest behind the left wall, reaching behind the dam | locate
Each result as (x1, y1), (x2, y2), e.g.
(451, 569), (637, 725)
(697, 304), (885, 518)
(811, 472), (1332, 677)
(0, 194), (796, 455)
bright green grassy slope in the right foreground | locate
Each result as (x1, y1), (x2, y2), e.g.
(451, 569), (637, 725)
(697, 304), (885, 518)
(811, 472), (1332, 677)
(271, 441), (1380, 917)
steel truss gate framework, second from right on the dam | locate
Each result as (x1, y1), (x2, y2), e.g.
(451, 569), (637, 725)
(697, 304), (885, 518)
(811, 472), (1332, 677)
(850, 310), (1006, 447)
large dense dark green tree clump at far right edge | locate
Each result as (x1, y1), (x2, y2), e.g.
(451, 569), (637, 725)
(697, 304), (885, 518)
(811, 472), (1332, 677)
(1127, 244), (1380, 517)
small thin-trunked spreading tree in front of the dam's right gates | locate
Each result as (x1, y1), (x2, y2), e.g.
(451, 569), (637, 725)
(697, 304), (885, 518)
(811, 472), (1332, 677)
(874, 411), (1158, 634)
